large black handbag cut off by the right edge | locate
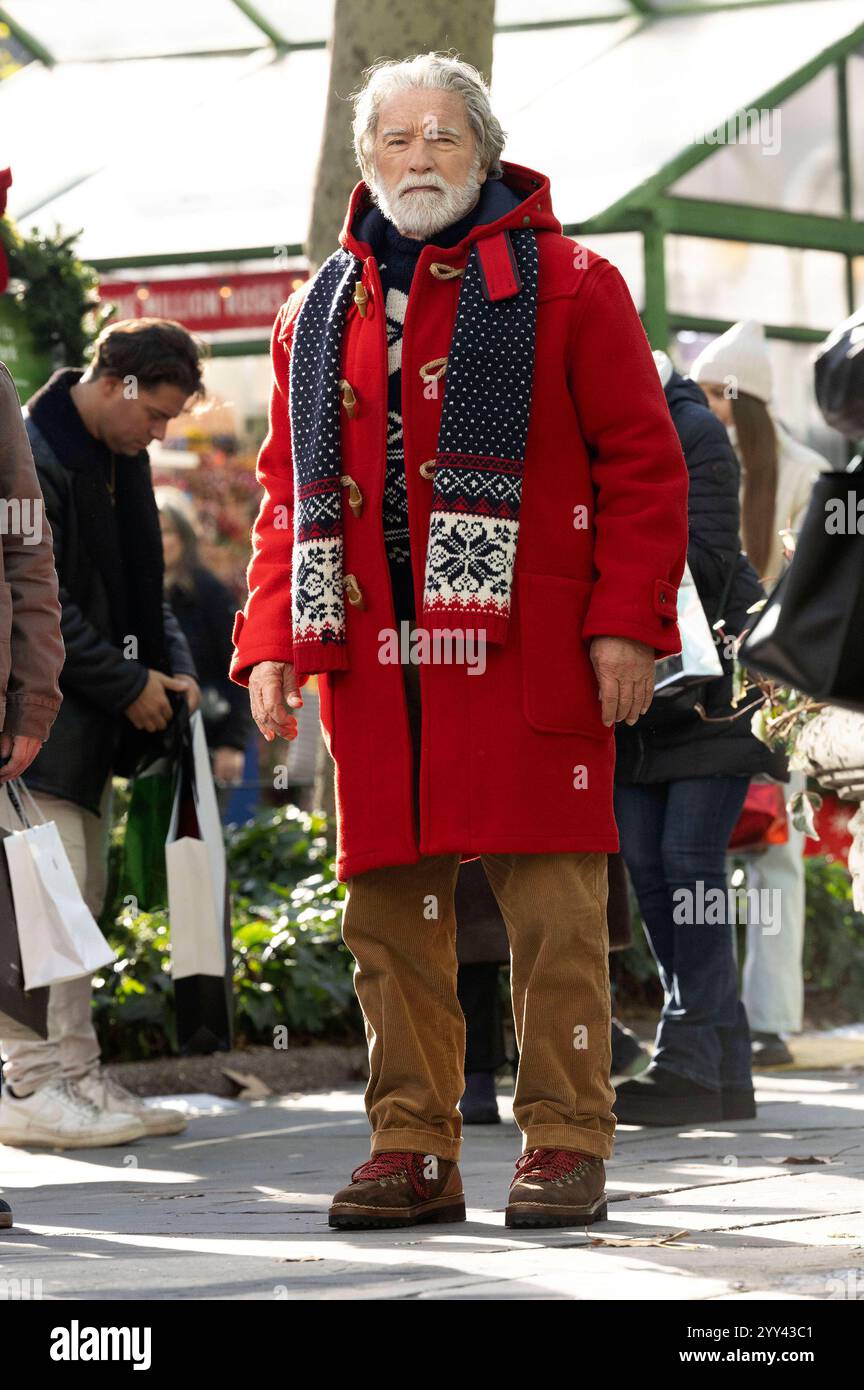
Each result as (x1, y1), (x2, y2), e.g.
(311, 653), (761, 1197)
(740, 457), (864, 710)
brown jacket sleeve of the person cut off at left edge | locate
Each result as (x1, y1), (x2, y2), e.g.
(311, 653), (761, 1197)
(0, 366), (65, 742)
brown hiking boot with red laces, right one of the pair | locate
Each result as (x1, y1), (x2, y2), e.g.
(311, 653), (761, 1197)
(504, 1148), (607, 1226)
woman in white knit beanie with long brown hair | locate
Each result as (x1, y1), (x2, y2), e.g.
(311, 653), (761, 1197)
(690, 318), (831, 1066)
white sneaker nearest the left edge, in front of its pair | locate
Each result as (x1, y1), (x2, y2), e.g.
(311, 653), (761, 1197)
(0, 1080), (147, 1148)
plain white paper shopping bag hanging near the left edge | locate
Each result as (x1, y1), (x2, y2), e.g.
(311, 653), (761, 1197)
(3, 783), (117, 990)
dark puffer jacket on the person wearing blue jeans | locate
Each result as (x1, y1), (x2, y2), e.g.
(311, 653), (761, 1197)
(615, 371), (789, 785)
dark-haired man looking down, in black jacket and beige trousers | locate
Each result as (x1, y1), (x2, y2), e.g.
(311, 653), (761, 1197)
(0, 320), (201, 1148)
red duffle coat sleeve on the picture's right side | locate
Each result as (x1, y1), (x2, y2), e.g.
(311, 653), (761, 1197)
(568, 261), (688, 657)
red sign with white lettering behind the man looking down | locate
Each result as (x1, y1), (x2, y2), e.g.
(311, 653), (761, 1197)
(99, 270), (308, 334)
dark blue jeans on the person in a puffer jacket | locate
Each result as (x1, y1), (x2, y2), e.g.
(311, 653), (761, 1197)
(615, 777), (753, 1090)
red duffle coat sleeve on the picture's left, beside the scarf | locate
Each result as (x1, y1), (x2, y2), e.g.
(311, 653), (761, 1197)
(229, 305), (308, 685)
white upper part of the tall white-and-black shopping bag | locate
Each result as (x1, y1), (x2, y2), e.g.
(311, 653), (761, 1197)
(165, 710), (225, 980)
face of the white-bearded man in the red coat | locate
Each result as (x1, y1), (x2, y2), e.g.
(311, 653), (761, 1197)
(372, 88), (486, 240)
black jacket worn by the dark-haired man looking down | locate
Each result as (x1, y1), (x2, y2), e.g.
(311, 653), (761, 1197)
(25, 370), (196, 815)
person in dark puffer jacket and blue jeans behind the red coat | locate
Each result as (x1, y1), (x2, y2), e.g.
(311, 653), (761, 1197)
(614, 353), (788, 1125)
